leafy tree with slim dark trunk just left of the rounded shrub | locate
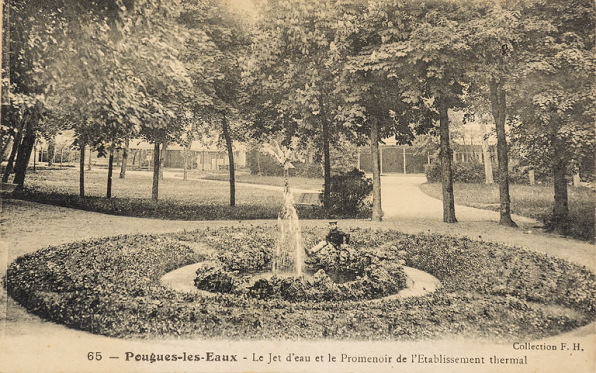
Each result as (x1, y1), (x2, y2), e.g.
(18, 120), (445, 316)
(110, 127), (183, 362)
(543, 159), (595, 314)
(247, 0), (352, 208)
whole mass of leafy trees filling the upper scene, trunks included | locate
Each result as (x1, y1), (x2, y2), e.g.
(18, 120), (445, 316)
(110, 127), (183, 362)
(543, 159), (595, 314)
(0, 0), (596, 230)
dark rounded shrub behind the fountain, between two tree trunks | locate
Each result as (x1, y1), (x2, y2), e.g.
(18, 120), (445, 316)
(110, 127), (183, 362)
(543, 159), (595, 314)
(320, 168), (372, 216)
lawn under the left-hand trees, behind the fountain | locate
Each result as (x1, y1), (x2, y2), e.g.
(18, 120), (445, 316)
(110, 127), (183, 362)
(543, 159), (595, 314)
(16, 169), (323, 220)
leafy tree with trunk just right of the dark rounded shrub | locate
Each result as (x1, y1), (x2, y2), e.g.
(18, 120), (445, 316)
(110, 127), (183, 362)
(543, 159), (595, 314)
(338, 3), (432, 221)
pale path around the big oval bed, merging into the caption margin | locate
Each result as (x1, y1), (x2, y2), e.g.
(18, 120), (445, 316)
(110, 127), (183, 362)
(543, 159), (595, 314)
(0, 176), (596, 372)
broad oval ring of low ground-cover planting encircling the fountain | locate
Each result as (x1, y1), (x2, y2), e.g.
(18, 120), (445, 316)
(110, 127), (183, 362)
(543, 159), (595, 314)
(5, 224), (596, 340)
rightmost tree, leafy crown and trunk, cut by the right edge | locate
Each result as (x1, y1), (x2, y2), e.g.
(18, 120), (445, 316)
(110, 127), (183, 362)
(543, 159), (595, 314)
(512, 0), (596, 233)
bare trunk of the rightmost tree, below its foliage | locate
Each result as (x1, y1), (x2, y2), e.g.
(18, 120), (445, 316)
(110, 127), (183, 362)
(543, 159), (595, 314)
(549, 131), (569, 234)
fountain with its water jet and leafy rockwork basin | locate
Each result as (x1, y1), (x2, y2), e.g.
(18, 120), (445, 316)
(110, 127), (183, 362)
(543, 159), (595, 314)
(186, 141), (408, 302)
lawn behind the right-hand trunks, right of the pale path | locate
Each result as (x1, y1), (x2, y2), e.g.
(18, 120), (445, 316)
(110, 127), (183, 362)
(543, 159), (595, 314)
(420, 183), (595, 241)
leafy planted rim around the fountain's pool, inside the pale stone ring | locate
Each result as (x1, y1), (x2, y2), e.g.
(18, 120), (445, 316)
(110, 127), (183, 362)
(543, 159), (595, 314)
(195, 235), (406, 302)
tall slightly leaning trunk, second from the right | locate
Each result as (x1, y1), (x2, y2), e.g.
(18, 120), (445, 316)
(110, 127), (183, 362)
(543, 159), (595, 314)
(490, 78), (517, 227)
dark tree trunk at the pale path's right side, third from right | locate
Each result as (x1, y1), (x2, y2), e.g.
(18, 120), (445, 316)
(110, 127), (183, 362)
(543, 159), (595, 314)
(438, 98), (457, 223)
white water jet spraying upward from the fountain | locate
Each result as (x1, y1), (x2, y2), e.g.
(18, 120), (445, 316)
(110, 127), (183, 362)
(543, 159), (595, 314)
(265, 141), (304, 276)
